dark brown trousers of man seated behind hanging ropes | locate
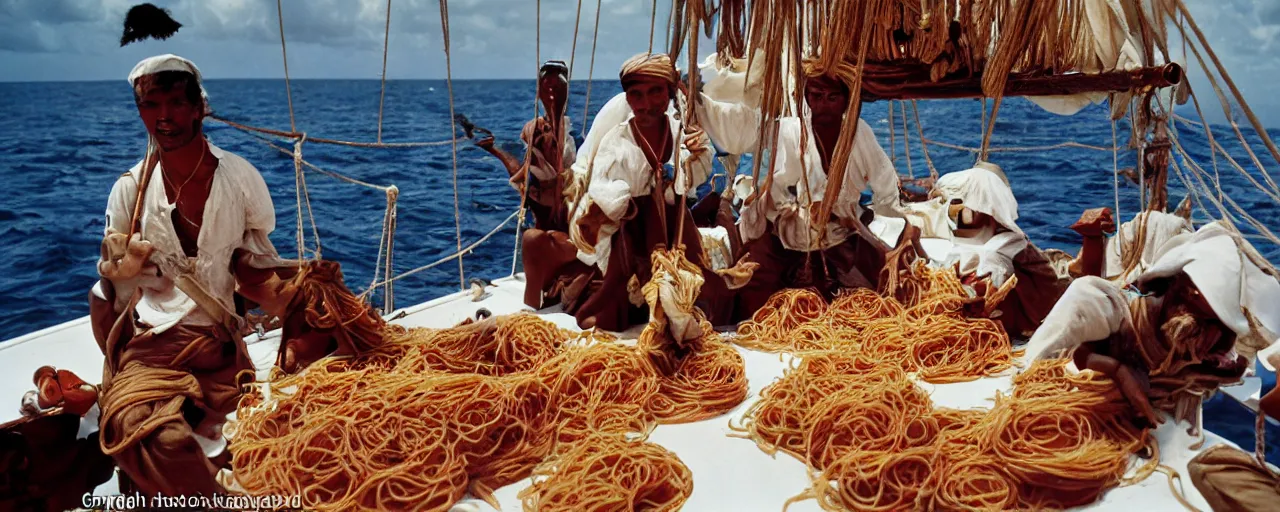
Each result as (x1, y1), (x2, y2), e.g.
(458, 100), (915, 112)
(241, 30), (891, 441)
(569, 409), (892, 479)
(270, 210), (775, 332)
(733, 223), (888, 321)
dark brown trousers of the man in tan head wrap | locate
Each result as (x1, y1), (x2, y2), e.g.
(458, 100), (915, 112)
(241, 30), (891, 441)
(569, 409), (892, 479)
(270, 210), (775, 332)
(566, 196), (728, 332)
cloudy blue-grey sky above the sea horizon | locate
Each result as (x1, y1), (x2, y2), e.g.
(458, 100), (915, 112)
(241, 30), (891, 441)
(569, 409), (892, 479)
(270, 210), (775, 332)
(0, 0), (1280, 125)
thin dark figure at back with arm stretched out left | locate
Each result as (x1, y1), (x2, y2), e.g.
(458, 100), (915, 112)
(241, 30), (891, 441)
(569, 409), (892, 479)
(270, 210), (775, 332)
(476, 60), (589, 310)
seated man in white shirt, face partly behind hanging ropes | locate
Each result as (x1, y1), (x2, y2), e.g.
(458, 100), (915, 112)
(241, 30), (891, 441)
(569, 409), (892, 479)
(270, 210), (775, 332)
(733, 76), (902, 320)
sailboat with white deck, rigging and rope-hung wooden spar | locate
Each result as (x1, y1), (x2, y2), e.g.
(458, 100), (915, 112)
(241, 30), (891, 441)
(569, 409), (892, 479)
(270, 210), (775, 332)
(0, 0), (1280, 511)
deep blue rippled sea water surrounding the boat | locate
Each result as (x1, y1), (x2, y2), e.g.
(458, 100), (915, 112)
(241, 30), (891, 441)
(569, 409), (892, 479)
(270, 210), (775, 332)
(0, 79), (1280, 462)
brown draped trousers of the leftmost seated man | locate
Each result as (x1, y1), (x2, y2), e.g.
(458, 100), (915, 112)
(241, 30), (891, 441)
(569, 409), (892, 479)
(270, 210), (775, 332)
(90, 288), (253, 495)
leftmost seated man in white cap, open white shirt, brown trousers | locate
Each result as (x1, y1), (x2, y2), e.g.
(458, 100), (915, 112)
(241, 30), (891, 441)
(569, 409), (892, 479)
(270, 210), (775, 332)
(90, 55), (307, 495)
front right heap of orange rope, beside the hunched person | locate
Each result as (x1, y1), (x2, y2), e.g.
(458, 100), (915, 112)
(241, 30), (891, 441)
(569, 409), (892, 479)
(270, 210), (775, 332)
(735, 358), (1155, 511)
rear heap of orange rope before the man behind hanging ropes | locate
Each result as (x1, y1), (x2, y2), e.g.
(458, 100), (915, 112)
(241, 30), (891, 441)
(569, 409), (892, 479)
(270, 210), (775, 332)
(735, 259), (1014, 383)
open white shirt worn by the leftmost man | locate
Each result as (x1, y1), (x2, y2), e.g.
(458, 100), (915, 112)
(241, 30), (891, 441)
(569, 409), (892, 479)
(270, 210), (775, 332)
(105, 142), (282, 332)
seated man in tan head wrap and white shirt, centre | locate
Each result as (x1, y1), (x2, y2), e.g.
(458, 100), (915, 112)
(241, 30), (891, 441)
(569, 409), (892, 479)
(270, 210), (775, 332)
(566, 54), (747, 330)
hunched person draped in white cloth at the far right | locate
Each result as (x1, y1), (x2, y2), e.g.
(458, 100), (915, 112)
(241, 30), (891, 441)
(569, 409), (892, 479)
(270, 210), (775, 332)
(1024, 223), (1280, 429)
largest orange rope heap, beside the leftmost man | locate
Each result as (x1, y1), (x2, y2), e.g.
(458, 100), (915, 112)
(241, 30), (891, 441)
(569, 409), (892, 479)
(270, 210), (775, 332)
(227, 314), (748, 511)
